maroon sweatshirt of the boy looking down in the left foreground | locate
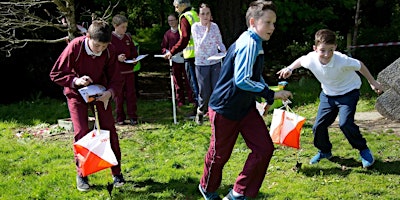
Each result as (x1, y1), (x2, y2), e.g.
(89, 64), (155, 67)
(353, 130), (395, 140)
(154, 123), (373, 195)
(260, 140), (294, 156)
(50, 36), (122, 101)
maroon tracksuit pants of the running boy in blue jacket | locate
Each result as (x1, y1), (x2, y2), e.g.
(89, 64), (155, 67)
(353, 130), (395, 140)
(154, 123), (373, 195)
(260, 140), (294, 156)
(200, 107), (274, 198)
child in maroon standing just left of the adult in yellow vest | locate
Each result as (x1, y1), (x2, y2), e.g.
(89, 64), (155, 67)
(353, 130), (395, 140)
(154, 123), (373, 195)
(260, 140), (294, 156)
(161, 14), (195, 107)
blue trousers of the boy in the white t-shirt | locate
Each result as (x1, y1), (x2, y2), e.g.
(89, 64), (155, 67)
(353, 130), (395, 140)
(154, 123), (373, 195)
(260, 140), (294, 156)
(313, 89), (368, 153)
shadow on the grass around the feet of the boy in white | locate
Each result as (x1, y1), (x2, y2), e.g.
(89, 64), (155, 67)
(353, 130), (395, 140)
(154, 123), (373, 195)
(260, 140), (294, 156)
(299, 156), (400, 176)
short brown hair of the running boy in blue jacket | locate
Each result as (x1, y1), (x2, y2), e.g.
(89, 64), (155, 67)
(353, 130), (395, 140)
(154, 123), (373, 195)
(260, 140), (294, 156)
(246, 0), (276, 27)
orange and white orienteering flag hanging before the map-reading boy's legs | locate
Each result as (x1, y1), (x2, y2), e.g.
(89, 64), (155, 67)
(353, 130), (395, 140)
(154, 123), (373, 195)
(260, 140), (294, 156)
(74, 130), (118, 176)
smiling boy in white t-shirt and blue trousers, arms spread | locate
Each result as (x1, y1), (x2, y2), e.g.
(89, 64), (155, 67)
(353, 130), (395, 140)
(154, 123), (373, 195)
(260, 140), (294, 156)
(277, 29), (383, 168)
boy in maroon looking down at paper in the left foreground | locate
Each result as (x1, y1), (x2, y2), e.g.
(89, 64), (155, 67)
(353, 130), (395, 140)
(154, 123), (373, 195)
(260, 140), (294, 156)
(50, 20), (125, 191)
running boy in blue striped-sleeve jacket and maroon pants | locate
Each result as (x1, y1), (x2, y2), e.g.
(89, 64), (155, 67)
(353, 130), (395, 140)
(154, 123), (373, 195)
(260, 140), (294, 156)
(199, 1), (292, 200)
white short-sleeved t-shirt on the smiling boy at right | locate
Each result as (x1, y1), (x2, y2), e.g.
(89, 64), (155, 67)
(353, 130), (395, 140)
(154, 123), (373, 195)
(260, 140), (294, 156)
(300, 51), (361, 96)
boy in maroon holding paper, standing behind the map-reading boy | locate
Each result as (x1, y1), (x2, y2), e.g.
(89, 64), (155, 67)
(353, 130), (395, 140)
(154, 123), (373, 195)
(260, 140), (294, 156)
(111, 15), (138, 125)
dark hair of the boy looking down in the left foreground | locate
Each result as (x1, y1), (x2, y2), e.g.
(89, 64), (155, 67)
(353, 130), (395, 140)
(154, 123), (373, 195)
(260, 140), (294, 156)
(88, 20), (112, 43)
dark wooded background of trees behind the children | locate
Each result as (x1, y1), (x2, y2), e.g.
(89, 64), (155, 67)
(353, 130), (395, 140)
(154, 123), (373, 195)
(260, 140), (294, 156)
(0, 0), (400, 104)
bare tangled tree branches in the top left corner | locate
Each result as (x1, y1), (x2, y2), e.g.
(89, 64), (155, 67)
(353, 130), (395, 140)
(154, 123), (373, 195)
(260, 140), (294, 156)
(0, 0), (119, 56)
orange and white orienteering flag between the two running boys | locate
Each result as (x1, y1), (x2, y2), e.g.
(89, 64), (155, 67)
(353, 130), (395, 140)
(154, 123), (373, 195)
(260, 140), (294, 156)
(269, 105), (306, 149)
